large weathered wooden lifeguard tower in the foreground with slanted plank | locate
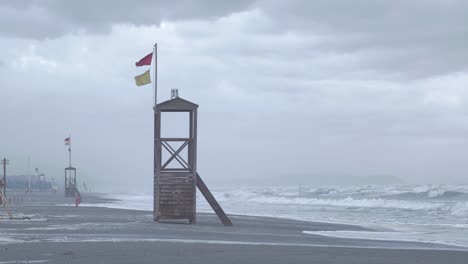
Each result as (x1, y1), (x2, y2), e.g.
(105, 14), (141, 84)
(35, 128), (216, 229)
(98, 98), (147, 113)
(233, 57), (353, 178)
(154, 90), (232, 226)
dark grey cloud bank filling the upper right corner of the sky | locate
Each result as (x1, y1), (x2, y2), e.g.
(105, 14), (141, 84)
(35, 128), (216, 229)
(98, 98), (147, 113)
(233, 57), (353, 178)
(254, 0), (468, 78)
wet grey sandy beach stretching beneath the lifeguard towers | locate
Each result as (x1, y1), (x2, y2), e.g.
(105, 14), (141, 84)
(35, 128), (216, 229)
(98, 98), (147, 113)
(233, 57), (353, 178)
(0, 193), (468, 263)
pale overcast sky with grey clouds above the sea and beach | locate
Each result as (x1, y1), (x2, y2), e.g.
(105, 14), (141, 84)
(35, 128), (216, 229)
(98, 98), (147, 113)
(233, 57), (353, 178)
(0, 0), (468, 192)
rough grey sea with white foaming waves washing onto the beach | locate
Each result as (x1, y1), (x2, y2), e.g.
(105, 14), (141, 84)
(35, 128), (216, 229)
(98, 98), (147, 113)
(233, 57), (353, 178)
(87, 185), (468, 248)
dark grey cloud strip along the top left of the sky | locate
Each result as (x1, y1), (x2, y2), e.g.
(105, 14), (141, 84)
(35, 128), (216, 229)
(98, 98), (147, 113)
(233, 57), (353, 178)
(0, 0), (251, 39)
